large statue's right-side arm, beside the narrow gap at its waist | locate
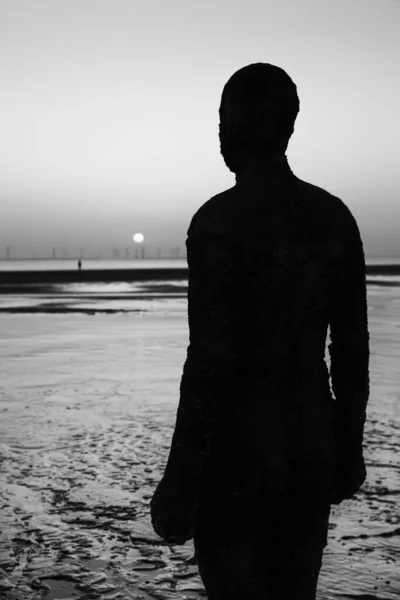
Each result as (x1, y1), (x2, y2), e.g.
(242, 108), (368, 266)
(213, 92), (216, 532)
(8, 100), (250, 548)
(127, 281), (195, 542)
(329, 207), (370, 498)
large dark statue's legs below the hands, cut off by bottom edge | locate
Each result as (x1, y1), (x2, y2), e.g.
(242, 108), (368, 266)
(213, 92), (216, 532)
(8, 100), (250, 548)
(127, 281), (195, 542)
(194, 497), (330, 600)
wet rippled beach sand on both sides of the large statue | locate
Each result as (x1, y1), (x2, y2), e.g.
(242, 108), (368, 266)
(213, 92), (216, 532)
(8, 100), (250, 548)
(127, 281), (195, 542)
(0, 286), (400, 600)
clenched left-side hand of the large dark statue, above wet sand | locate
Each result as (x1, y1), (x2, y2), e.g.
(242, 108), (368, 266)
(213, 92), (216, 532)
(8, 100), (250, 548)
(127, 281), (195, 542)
(150, 477), (196, 544)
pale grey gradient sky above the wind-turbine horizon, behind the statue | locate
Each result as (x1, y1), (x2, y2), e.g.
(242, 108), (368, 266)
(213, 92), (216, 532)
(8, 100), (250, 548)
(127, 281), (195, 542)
(0, 0), (400, 255)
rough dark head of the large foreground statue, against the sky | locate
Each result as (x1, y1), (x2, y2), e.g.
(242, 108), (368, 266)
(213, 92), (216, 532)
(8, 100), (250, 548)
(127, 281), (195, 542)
(219, 63), (300, 173)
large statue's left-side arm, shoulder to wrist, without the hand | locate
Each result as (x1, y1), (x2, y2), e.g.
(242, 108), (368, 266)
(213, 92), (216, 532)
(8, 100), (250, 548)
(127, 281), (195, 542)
(166, 213), (242, 497)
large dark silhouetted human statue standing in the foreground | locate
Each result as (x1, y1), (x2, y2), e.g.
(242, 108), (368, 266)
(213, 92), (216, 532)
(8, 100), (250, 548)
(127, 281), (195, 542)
(150, 63), (369, 600)
